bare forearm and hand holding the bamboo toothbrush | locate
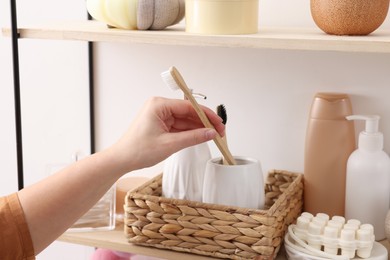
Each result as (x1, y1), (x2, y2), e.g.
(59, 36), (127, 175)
(19, 98), (224, 254)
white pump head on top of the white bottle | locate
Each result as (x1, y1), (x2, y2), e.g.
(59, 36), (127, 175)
(346, 115), (383, 150)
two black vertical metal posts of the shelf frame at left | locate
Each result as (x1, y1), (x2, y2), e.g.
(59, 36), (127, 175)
(10, 0), (96, 190)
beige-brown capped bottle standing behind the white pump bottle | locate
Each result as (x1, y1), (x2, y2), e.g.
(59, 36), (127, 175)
(304, 93), (356, 216)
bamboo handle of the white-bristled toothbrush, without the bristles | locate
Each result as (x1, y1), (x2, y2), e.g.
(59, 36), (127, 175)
(171, 67), (237, 165)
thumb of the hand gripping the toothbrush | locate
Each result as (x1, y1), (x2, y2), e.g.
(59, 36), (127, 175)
(173, 128), (217, 150)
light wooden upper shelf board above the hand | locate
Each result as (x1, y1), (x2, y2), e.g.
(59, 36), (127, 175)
(3, 21), (390, 53)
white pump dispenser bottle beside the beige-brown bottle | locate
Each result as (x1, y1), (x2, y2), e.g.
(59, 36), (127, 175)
(345, 115), (390, 240)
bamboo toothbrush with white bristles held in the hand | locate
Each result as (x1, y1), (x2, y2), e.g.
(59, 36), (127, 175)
(161, 67), (237, 165)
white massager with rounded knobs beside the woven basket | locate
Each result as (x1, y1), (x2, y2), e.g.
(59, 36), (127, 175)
(286, 212), (382, 259)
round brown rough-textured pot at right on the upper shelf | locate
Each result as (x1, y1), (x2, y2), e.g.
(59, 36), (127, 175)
(310, 0), (390, 35)
